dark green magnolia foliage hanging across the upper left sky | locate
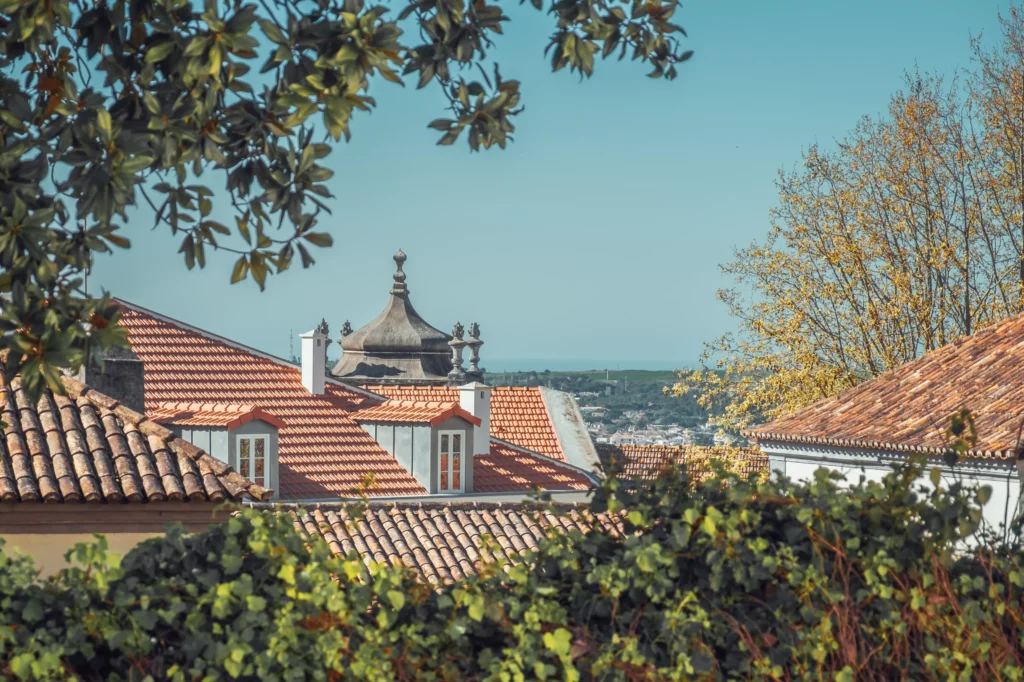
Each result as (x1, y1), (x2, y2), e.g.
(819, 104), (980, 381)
(0, 0), (691, 392)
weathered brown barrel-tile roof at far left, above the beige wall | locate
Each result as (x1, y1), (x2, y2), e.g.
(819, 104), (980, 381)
(0, 377), (272, 503)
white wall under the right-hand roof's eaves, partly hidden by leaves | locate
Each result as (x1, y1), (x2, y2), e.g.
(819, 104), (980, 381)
(759, 441), (1021, 528)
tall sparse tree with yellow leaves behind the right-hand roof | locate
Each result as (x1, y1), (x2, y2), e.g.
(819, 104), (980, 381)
(673, 8), (1024, 430)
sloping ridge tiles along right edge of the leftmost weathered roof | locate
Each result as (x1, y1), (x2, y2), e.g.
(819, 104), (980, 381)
(60, 376), (273, 501)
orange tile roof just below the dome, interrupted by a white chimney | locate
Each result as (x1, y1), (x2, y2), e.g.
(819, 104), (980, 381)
(366, 386), (565, 461)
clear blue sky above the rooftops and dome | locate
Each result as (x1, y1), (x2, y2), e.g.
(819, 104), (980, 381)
(90, 0), (1008, 371)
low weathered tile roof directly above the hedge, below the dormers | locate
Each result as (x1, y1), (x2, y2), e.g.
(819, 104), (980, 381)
(288, 502), (622, 585)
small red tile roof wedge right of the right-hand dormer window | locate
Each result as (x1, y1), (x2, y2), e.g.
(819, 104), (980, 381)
(473, 441), (594, 493)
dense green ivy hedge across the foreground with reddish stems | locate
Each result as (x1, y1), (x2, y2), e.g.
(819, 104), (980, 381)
(0, 458), (1024, 681)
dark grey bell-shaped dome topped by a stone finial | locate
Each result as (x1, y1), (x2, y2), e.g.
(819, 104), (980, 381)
(331, 249), (453, 384)
